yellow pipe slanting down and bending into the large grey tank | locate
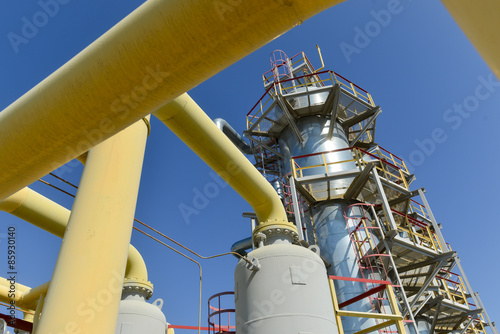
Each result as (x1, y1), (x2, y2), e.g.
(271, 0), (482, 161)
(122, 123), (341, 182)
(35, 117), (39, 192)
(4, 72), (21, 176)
(154, 93), (296, 240)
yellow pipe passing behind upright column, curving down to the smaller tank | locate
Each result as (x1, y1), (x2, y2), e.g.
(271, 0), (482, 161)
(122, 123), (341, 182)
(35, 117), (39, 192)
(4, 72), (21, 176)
(0, 187), (153, 290)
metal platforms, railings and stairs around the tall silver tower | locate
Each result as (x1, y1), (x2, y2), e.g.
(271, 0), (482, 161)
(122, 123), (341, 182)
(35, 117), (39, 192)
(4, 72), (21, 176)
(244, 51), (497, 334)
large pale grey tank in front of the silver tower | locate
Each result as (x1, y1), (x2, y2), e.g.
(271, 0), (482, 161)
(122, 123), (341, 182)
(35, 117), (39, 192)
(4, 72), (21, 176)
(234, 243), (338, 334)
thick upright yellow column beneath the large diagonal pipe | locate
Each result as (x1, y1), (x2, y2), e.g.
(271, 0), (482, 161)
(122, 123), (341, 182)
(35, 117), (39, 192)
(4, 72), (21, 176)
(37, 120), (147, 334)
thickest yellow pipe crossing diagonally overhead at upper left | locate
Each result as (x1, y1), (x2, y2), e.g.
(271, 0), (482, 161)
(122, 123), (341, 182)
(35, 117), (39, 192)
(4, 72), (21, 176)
(0, 0), (343, 199)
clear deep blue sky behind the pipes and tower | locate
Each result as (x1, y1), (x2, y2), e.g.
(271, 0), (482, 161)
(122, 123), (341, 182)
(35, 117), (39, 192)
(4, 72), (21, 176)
(0, 0), (500, 333)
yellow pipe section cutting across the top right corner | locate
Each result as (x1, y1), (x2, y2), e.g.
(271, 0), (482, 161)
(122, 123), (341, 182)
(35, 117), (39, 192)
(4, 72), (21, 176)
(441, 0), (500, 79)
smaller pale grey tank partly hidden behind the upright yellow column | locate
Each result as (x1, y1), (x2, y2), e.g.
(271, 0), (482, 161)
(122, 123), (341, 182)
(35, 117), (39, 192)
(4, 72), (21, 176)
(115, 291), (170, 334)
